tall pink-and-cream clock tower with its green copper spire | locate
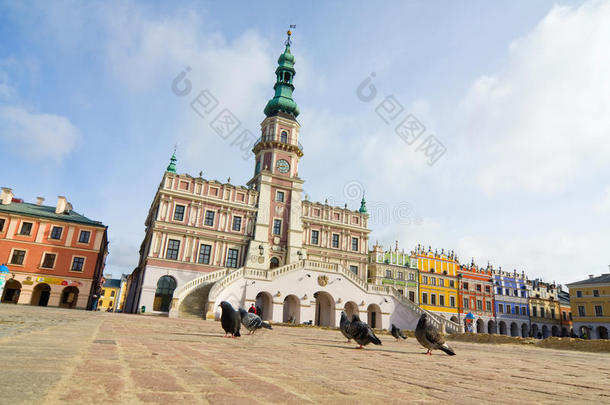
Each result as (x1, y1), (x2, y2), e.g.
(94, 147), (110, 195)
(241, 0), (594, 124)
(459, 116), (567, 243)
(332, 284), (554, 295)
(247, 31), (305, 269)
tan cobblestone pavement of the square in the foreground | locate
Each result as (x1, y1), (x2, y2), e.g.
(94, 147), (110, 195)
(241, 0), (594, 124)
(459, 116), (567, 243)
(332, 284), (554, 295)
(0, 304), (610, 404)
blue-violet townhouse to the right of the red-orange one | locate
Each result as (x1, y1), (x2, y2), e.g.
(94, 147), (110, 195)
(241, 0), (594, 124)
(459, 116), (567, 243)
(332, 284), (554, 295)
(489, 267), (530, 337)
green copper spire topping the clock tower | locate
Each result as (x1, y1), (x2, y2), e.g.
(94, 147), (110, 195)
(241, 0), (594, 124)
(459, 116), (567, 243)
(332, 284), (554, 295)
(265, 34), (299, 118)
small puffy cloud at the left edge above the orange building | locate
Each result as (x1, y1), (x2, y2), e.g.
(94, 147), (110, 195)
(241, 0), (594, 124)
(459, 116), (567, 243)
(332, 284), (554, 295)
(0, 106), (80, 163)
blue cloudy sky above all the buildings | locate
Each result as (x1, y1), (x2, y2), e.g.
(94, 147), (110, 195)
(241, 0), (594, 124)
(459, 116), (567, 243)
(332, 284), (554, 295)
(0, 0), (610, 284)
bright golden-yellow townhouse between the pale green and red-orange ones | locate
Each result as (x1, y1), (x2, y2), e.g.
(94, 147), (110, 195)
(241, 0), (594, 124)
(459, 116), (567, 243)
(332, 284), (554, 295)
(412, 245), (459, 322)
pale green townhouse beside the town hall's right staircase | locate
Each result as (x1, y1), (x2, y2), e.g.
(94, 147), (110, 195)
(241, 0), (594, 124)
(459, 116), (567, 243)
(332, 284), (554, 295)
(367, 242), (419, 304)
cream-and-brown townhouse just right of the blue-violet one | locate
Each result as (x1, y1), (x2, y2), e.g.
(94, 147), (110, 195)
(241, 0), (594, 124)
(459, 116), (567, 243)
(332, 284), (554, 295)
(527, 279), (561, 339)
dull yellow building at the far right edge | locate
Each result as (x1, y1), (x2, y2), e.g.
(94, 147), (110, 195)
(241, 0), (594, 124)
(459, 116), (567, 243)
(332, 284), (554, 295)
(567, 273), (610, 339)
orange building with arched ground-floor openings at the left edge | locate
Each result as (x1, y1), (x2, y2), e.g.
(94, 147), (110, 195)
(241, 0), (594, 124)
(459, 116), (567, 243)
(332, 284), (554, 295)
(0, 188), (108, 309)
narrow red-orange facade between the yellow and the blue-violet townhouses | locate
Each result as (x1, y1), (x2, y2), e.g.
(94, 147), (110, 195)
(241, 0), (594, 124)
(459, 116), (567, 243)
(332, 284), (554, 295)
(457, 260), (495, 333)
